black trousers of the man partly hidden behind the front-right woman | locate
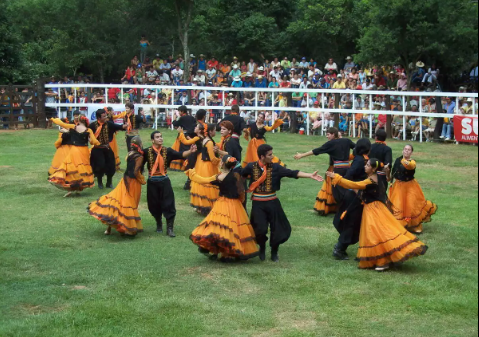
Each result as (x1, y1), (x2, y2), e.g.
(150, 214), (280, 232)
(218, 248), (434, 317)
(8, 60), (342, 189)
(334, 190), (364, 250)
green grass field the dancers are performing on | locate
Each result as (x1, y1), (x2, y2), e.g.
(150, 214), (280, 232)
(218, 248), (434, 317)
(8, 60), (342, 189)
(0, 130), (478, 337)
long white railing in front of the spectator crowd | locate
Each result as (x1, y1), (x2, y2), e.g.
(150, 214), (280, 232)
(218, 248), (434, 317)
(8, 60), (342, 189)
(45, 84), (479, 142)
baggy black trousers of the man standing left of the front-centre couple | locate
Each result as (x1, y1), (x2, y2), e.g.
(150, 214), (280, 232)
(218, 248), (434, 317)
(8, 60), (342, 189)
(147, 178), (176, 222)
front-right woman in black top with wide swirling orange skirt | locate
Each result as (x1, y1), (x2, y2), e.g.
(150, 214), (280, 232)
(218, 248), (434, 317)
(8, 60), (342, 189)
(327, 158), (428, 272)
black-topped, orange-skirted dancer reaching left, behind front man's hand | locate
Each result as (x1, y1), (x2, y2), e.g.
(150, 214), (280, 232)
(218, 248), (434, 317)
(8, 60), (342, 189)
(294, 128), (356, 215)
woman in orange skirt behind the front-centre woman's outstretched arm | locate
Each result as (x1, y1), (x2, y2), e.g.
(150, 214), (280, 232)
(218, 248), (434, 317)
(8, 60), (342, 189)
(190, 124), (220, 216)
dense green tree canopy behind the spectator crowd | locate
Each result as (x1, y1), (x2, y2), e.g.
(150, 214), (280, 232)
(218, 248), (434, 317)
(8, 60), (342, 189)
(0, 0), (478, 83)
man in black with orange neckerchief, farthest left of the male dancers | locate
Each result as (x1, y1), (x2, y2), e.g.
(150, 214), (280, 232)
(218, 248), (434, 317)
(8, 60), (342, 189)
(90, 109), (127, 190)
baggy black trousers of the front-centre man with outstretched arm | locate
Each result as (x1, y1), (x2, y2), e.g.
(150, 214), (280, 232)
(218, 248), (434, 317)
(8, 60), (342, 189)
(251, 199), (292, 247)
